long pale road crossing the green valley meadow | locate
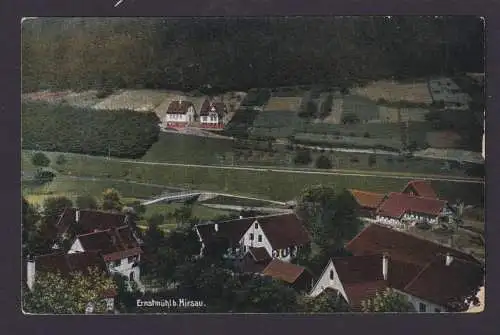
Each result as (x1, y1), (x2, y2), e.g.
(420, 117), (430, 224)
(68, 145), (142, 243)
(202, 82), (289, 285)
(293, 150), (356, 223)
(22, 153), (484, 184)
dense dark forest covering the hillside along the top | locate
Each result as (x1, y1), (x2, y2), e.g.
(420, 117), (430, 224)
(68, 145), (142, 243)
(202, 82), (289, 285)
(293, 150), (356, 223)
(22, 16), (484, 92)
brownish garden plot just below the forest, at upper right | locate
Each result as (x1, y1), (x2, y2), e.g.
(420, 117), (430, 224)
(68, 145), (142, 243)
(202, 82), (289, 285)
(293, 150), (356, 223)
(351, 80), (433, 104)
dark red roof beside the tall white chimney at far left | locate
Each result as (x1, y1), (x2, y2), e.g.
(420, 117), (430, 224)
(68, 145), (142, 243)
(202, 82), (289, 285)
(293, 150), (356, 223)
(35, 252), (107, 275)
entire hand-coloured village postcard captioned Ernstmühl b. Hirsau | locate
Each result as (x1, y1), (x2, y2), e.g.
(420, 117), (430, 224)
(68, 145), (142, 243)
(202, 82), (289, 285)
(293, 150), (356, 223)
(21, 16), (486, 315)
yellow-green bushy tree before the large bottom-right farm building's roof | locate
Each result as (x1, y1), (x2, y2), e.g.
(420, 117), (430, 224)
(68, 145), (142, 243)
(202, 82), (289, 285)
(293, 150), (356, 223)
(361, 289), (414, 313)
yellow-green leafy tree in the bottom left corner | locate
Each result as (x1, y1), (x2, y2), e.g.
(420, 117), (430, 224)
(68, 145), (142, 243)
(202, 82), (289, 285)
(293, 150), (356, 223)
(23, 269), (116, 314)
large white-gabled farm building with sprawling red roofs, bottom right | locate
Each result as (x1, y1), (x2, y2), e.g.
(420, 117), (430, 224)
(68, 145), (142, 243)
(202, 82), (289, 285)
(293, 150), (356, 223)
(310, 224), (484, 313)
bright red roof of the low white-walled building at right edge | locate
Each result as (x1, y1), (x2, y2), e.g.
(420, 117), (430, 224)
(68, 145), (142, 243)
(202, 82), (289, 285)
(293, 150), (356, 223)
(377, 192), (446, 218)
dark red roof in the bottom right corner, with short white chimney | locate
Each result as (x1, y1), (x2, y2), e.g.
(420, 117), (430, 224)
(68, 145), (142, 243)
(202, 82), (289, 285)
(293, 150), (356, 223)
(404, 256), (484, 311)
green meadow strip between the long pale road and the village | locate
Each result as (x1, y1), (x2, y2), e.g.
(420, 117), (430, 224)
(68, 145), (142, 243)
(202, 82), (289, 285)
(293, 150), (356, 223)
(20, 154), (483, 203)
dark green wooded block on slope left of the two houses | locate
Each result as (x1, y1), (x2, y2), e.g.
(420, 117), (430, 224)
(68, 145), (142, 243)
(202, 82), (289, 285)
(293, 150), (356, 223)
(21, 102), (160, 158)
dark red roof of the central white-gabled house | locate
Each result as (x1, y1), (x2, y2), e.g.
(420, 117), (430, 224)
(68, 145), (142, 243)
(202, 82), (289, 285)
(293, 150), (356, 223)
(257, 213), (311, 249)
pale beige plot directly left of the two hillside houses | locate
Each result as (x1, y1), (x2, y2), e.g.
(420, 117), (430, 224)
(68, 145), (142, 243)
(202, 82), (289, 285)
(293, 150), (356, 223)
(93, 90), (172, 112)
